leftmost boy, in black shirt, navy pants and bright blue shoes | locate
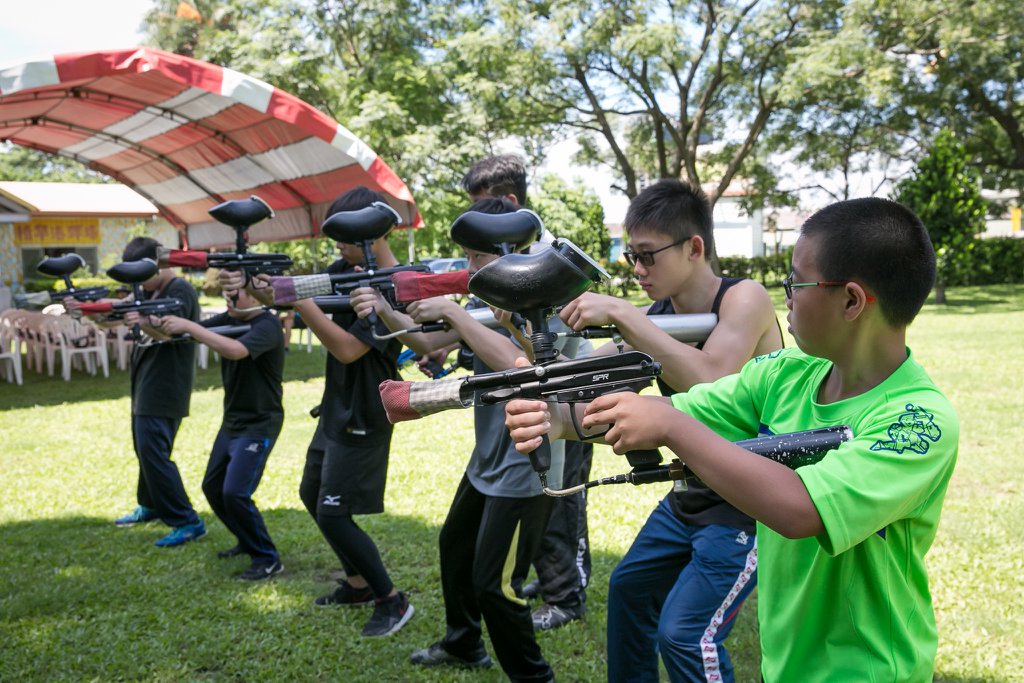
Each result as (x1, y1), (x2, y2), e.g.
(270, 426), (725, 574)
(115, 238), (206, 548)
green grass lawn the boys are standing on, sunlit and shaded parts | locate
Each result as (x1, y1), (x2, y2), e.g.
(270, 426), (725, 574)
(0, 287), (1024, 681)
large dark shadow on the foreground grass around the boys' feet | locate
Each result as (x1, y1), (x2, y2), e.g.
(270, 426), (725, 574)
(0, 509), (671, 683)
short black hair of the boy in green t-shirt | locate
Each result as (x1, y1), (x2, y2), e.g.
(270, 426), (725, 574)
(801, 197), (935, 327)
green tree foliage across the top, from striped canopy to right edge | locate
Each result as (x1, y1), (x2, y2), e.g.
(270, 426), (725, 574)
(7, 0), (1024, 253)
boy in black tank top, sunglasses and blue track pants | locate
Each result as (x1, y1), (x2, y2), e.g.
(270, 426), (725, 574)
(561, 179), (782, 681)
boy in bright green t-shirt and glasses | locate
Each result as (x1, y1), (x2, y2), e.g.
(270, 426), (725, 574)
(507, 194), (959, 683)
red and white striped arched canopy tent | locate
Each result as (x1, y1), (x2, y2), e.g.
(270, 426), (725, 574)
(0, 48), (422, 249)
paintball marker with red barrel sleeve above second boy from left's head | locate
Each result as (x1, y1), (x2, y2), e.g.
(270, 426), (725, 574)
(157, 195), (292, 285)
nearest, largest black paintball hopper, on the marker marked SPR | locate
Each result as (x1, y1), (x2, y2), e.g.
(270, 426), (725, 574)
(468, 237), (608, 313)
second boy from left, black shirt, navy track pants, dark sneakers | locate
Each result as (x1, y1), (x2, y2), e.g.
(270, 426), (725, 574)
(159, 290), (285, 581)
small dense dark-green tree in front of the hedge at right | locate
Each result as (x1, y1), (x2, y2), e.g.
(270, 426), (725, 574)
(894, 130), (986, 303)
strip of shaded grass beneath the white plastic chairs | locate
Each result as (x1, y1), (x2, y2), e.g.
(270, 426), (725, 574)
(0, 347), (324, 411)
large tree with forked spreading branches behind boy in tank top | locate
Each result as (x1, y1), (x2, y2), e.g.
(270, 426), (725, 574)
(460, 0), (856, 208)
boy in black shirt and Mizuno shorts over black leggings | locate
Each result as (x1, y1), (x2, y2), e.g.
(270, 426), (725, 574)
(218, 186), (414, 637)
